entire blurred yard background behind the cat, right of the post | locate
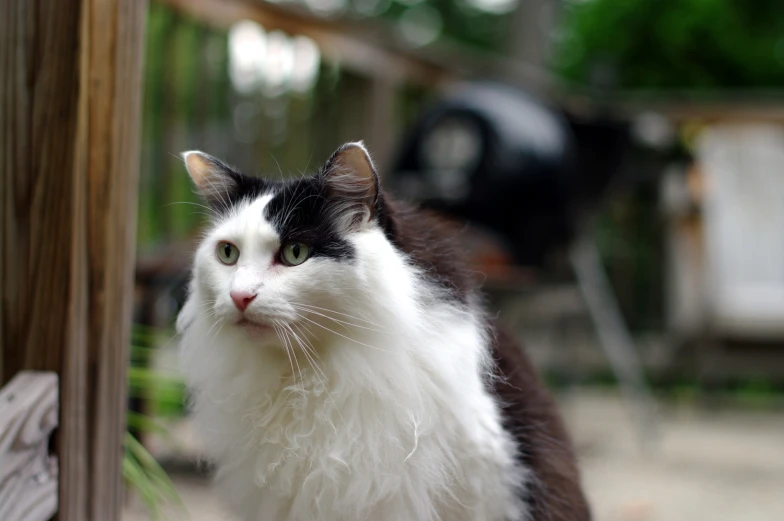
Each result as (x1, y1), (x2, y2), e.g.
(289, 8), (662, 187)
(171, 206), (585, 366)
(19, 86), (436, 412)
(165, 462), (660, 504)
(124, 0), (784, 521)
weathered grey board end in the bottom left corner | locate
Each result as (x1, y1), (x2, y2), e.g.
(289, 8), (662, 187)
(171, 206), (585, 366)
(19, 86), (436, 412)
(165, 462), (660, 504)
(0, 371), (58, 521)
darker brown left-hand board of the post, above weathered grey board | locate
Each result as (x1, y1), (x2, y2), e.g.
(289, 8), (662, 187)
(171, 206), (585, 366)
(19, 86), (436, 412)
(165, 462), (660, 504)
(0, 0), (88, 519)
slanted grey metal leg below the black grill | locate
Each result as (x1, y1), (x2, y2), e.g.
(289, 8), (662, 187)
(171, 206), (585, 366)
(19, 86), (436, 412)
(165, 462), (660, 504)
(571, 234), (658, 448)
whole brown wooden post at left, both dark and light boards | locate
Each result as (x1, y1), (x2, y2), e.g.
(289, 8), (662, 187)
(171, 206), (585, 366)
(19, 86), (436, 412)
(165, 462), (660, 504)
(0, 0), (146, 521)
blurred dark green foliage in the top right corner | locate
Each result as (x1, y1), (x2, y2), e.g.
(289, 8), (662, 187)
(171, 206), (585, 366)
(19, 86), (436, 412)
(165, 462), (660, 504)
(555, 0), (784, 89)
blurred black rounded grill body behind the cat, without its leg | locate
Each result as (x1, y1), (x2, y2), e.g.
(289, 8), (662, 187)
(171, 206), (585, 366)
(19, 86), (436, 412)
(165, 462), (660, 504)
(390, 82), (628, 266)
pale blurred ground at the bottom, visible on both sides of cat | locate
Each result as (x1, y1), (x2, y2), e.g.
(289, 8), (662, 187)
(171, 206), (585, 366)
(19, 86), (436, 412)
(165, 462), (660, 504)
(123, 390), (784, 521)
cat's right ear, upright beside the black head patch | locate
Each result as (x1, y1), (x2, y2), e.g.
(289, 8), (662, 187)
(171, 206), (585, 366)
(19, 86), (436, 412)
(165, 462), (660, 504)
(321, 141), (379, 223)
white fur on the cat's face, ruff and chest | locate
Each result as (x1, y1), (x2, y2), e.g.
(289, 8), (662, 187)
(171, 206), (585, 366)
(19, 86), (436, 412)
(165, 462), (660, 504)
(178, 194), (528, 521)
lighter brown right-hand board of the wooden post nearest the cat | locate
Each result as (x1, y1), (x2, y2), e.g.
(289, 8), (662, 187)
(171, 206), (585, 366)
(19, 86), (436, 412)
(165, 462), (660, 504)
(80, 0), (147, 521)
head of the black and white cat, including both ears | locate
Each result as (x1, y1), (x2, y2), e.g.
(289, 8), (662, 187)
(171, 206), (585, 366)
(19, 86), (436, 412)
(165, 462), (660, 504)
(183, 142), (384, 344)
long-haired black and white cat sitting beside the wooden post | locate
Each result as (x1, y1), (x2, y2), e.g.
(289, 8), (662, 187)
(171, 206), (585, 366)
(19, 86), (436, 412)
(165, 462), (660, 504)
(177, 142), (590, 521)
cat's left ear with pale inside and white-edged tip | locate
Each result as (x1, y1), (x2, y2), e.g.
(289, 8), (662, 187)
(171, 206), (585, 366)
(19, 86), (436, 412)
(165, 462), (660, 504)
(182, 150), (242, 208)
